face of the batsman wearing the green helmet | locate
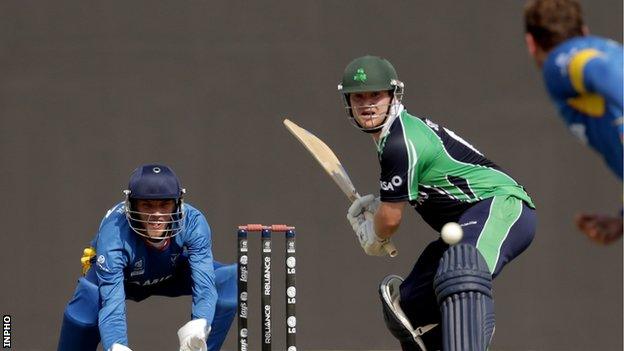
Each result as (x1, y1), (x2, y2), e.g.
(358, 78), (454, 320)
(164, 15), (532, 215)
(349, 90), (392, 128)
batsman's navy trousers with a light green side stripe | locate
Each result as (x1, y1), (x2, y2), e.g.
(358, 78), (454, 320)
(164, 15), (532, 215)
(400, 197), (536, 349)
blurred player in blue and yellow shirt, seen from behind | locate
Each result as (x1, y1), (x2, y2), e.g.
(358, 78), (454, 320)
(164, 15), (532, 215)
(524, 0), (624, 244)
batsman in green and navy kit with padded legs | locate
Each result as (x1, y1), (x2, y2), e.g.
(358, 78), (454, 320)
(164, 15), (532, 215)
(338, 56), (536, 351)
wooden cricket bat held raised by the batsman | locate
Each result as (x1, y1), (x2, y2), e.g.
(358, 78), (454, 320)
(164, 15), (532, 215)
(284, 119), (398, 257)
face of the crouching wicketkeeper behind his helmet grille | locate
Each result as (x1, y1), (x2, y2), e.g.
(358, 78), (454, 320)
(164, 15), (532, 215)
(136, 200), (175, 238)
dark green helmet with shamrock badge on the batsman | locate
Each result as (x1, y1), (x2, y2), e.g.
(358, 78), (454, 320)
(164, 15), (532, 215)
(338, 55), (403, 133)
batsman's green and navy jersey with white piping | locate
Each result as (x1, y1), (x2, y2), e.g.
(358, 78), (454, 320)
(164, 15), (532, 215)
(377, 109), (535, 231)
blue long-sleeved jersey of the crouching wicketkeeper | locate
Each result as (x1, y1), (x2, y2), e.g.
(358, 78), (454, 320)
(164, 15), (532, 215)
(93, 203), (217, 350)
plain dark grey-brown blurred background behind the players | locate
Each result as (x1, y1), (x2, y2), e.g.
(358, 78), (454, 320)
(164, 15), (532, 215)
(0, 0), (623, 351)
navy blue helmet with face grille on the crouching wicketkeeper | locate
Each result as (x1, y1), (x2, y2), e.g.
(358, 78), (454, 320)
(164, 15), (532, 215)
(124, 164), (186, 240)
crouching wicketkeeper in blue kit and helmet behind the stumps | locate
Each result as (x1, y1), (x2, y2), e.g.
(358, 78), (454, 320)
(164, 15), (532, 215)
(58, 164), (237, 351)
